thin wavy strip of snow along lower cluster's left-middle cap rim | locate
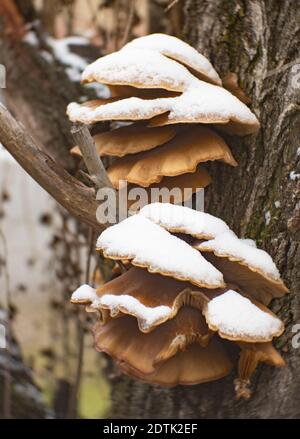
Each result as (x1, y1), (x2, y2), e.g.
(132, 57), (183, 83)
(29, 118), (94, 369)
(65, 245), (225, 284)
(95, 294), (172, 330)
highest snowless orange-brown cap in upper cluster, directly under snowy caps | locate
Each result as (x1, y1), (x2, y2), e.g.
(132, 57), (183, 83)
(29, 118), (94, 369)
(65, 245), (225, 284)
(71, 124), (176, 157)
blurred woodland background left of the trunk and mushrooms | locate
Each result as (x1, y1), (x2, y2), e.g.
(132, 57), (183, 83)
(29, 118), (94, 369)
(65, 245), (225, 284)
(0, 0), (184, 418)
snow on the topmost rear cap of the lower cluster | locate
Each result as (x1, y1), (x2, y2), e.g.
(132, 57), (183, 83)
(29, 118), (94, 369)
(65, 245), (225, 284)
(139, 203), (229, 239)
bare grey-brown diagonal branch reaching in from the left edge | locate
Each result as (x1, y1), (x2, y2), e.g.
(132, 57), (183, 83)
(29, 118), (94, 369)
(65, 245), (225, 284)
(0, 104), (105, 232)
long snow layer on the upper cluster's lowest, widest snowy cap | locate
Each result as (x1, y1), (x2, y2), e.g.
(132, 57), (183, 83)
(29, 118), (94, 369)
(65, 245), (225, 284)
(67, 78), (259, 133)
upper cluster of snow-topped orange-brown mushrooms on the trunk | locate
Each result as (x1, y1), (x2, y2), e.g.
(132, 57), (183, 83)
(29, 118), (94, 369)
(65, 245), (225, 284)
(67, 34), (259, 202)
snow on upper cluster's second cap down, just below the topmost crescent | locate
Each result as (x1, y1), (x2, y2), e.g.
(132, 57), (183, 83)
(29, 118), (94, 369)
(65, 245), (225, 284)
(82, 49), (197, 92)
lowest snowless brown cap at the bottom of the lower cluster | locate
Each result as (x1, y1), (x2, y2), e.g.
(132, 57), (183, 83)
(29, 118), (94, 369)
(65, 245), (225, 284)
(120, 337), (232, 387)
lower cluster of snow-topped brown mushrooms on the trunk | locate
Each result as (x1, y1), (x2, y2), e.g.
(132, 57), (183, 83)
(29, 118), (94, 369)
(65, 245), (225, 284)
(71, 203), (288, 398)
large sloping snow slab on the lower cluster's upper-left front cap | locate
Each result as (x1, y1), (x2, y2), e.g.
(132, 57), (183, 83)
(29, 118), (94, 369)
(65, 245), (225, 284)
(97, 215), (225, 288)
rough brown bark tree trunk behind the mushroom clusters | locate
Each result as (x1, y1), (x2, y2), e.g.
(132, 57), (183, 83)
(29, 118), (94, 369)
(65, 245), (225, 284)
(112, 0), (300, 418)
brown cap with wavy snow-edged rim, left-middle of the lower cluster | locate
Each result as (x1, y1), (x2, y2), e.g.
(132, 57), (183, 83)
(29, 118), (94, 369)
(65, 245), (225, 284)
(88, 267), (214, 332)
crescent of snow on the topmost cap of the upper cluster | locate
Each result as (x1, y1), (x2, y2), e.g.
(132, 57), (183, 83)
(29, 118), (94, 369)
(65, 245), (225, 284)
(122, 34), (222, 85)
